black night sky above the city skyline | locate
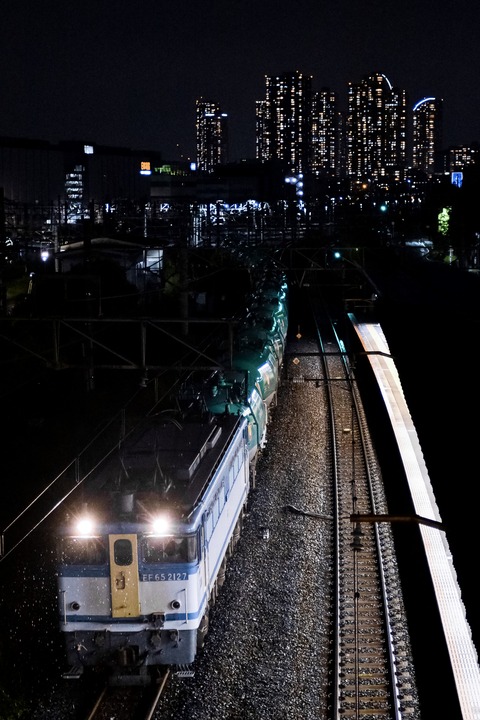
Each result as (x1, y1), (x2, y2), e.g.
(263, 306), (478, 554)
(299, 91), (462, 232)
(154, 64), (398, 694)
(0, 0), (480, 161)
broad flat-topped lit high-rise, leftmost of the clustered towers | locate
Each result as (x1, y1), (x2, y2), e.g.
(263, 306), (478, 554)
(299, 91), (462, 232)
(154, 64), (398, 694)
(255, 70), (312, 173)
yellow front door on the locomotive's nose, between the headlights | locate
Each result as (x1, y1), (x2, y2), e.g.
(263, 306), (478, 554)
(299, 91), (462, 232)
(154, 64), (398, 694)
(108, 535), (140, 617)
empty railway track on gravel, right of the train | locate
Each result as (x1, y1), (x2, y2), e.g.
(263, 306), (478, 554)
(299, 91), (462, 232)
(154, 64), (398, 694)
(308, 290), (420, 720)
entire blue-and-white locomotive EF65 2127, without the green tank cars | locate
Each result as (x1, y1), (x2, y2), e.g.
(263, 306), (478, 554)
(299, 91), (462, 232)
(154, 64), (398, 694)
(56, 413), (250, 684)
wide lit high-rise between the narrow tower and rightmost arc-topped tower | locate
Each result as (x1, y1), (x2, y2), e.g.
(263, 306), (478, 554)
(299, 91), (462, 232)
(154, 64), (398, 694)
(347, 73), (407, 181)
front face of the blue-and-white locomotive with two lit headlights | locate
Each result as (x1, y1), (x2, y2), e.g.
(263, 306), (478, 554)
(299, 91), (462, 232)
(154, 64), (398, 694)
(58, 500), (204, 670)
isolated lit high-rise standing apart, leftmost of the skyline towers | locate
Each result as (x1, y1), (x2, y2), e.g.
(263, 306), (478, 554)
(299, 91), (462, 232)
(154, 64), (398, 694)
(196, 98), (228, 172)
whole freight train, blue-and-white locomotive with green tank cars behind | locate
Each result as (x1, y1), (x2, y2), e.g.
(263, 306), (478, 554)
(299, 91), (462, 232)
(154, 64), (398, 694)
(55, 274), (288, 684)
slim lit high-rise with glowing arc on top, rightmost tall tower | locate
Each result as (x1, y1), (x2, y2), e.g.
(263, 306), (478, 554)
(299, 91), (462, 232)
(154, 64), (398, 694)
(412, 97), (443, 177)
